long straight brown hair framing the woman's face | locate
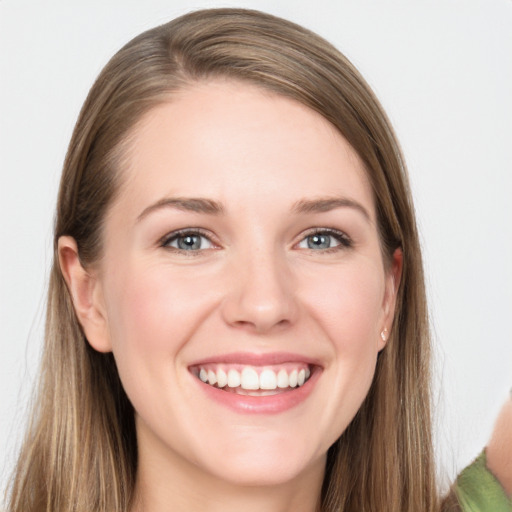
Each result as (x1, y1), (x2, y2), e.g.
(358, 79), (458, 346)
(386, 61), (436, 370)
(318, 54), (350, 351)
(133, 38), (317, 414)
(8, 9), (438, 512)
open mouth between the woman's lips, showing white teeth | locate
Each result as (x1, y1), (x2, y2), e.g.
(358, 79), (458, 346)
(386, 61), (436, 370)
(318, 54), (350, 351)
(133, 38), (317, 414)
(190, 363), (314, 396)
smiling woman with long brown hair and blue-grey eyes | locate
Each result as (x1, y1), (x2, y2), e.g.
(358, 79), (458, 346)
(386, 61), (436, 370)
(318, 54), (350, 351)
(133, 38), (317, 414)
(5, 10), (512, 511)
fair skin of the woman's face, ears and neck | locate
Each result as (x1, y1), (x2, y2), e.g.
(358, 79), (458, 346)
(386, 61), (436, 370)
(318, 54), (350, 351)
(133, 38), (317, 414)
(59, 81), (402, 512)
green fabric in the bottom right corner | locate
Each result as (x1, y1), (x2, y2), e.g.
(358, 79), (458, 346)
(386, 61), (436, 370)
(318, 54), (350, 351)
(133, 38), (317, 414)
(455, 452), (512, 512)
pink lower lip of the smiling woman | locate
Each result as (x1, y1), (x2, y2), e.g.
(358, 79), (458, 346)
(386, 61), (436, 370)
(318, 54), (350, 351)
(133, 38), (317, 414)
(193, 368), (321, 414)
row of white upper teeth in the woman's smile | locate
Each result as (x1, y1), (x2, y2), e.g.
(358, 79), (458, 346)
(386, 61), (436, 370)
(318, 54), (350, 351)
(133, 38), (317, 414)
(196, 366), (311, 390)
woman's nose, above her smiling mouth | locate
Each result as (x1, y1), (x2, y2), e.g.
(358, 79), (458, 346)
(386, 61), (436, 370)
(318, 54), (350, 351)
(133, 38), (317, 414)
(222, 252), (298, 334)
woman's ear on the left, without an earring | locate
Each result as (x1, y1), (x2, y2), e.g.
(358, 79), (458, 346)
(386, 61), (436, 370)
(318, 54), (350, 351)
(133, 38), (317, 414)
(58, 236), (112, 352)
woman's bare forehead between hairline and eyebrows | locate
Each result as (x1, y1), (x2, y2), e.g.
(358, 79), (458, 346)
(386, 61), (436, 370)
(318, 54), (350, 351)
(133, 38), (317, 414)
(114, 80), (374, 216)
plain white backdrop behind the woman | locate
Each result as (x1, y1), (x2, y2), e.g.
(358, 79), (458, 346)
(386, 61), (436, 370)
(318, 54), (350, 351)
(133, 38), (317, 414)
(0, 0), (512, 496)
